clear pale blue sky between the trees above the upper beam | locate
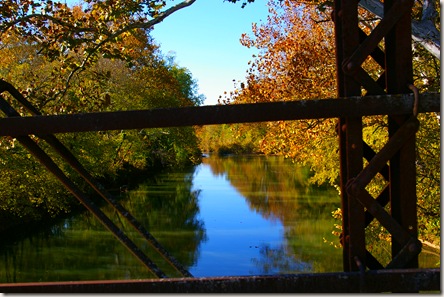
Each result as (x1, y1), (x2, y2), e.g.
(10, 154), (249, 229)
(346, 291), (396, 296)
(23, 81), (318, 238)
(151, 0), (268, 105)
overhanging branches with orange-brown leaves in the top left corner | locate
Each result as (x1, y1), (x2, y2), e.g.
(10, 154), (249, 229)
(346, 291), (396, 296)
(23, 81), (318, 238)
(0, 0), (195, 94)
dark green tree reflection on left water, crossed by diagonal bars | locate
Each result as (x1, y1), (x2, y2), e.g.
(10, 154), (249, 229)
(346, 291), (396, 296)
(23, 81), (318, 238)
(0, 168), (205, 282)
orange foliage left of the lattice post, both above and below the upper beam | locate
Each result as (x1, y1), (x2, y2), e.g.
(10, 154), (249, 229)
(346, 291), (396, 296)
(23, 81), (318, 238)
(222, 0), (337, 176)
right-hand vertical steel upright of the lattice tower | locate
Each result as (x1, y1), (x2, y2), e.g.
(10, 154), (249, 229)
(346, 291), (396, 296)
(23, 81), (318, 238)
(384, 0), (418, 268)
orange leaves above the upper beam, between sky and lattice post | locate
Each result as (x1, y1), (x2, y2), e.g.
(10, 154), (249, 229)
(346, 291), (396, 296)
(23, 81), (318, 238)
(241, 1), (335, 102)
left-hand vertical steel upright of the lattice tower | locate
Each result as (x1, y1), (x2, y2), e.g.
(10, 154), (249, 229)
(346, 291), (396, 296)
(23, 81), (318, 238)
(334, 0), (365, 271)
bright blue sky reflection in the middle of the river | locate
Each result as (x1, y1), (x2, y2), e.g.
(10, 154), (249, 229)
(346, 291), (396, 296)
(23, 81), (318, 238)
(190, 164), (300, 276)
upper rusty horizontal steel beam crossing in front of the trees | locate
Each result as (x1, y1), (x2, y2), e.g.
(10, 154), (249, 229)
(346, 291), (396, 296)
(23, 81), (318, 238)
(0, 94), (440, 136)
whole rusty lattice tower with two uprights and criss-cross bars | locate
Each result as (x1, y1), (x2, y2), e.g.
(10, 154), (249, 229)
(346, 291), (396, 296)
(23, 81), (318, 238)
(333, 0), (421, 271)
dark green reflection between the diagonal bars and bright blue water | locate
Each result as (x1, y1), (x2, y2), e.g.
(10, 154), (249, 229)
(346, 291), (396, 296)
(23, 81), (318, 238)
(125, 168), (206, 267)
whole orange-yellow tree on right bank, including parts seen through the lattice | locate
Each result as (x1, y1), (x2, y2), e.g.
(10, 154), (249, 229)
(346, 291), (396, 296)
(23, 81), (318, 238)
(225, 0), (440, 249)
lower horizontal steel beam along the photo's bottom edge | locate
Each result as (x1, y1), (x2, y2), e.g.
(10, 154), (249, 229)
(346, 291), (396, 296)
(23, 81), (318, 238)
(0, 269), (441, 293)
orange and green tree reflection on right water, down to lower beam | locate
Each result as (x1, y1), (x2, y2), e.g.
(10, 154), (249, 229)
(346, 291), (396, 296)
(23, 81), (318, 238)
(204, 156), (342, 274)
